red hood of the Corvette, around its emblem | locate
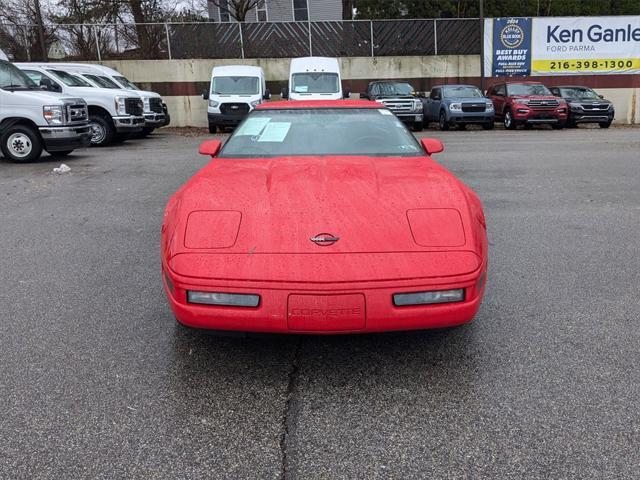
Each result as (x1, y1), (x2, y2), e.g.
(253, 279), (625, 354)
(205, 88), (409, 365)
(163, 157), (480, 257)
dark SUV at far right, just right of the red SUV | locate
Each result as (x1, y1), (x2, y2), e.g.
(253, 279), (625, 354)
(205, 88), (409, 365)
(550, 85), (615, 128)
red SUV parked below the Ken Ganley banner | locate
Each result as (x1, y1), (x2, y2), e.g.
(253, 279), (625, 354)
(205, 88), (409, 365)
(487, 82), (568, 130)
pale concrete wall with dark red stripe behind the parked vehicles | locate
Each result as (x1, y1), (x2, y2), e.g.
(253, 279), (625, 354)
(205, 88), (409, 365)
(103, 55), (640, 127)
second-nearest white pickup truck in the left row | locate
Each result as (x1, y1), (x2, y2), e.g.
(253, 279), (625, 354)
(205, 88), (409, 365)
(15, 63), (144, 147)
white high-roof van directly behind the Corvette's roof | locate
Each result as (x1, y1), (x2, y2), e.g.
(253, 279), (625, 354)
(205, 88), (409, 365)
(282, 57), (350, 100)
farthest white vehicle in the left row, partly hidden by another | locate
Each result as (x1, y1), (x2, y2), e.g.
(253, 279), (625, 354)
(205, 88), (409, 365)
(45, 63), (171, 135)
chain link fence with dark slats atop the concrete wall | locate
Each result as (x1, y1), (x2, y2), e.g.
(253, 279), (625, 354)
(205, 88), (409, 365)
(0, 19), (480, 61)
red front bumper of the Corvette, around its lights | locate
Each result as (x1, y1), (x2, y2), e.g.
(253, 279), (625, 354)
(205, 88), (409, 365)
(162, 263), (486, 335)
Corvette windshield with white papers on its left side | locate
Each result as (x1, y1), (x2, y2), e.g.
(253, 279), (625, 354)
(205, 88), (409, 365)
(220, 108), (424, 158)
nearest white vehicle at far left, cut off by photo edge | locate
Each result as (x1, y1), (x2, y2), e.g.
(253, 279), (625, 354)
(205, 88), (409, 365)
(0, 60), (91, 162)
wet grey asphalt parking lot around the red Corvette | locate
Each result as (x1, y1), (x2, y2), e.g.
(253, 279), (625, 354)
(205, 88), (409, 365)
(0, 128), (640, 479)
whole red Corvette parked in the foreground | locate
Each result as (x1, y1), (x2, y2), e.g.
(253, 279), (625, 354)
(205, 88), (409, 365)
(161, 101), (487, 334)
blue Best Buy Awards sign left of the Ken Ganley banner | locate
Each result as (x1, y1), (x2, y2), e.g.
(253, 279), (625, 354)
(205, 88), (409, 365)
(491, 17), (531, 77)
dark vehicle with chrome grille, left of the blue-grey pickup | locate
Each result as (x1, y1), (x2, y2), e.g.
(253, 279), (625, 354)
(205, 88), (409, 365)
(360, 80), (424, 131)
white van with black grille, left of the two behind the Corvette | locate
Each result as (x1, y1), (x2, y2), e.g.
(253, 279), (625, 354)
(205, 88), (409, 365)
(202, 65), (271, 133)
